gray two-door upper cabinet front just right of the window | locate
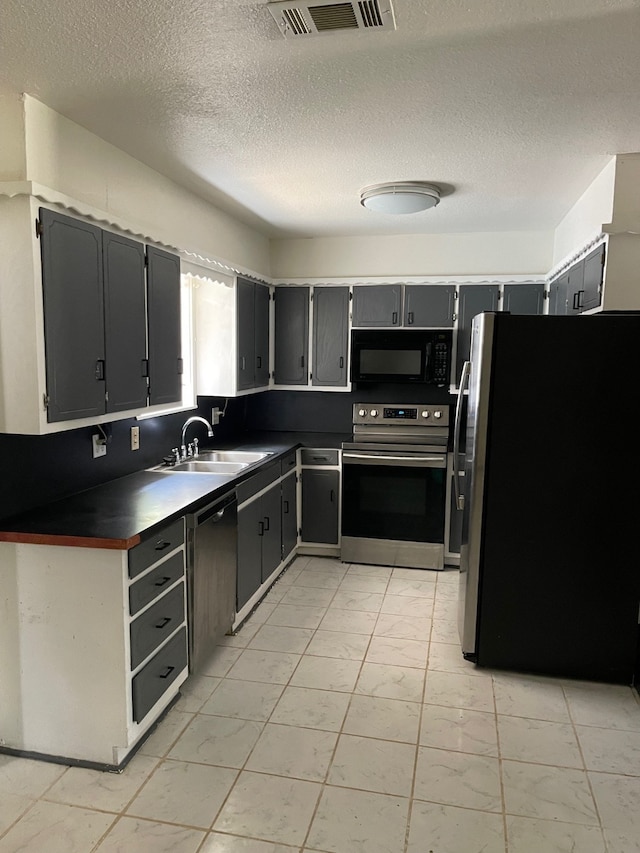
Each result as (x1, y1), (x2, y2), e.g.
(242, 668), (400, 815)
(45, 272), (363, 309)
(237, 278), (269, 391)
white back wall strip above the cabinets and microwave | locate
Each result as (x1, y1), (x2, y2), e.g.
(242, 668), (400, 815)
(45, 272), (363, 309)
(271, 231), (553, 281)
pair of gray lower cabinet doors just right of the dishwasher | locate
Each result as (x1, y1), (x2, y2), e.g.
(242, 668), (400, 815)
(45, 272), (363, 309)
(237, 482), (282, 610)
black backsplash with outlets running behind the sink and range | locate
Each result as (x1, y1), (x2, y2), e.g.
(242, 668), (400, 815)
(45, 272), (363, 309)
(0, 385), (455, 518)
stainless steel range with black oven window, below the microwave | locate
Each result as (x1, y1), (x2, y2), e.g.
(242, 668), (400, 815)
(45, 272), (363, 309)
(341, 403), (449, 569)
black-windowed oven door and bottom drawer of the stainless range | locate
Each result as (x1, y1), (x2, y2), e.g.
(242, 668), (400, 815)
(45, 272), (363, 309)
(341, 449), (447, 569)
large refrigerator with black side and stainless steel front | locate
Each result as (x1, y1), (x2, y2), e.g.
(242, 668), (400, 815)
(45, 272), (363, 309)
(455, 312), (640, 684)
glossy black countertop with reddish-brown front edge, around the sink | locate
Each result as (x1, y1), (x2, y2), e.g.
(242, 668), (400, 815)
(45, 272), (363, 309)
(0, 432), (350, 550)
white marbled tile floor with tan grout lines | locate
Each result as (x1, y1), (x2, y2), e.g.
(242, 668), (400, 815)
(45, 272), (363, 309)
(0, 557), (640, 853)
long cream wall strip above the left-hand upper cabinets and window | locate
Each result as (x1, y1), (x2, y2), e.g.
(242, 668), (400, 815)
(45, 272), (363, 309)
(24, 96), (270, 276)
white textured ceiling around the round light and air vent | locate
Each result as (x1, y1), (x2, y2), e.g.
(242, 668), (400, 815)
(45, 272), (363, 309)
(0, 0), (640, 237)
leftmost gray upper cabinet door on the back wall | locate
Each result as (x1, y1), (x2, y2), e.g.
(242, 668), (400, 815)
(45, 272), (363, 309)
(275, 287), (309, 385)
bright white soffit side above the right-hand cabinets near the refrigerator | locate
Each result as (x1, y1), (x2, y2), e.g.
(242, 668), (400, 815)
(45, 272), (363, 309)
(550, 157), (616, 267)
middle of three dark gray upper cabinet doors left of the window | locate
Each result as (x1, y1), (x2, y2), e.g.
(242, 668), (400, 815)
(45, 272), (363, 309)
(102, 231), (148, 412)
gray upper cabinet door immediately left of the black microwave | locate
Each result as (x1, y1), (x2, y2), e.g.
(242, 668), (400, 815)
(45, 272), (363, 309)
(311, 287), (349, 387)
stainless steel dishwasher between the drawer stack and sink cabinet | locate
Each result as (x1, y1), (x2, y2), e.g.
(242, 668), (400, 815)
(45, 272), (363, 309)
(187, 492), (238, 672)
